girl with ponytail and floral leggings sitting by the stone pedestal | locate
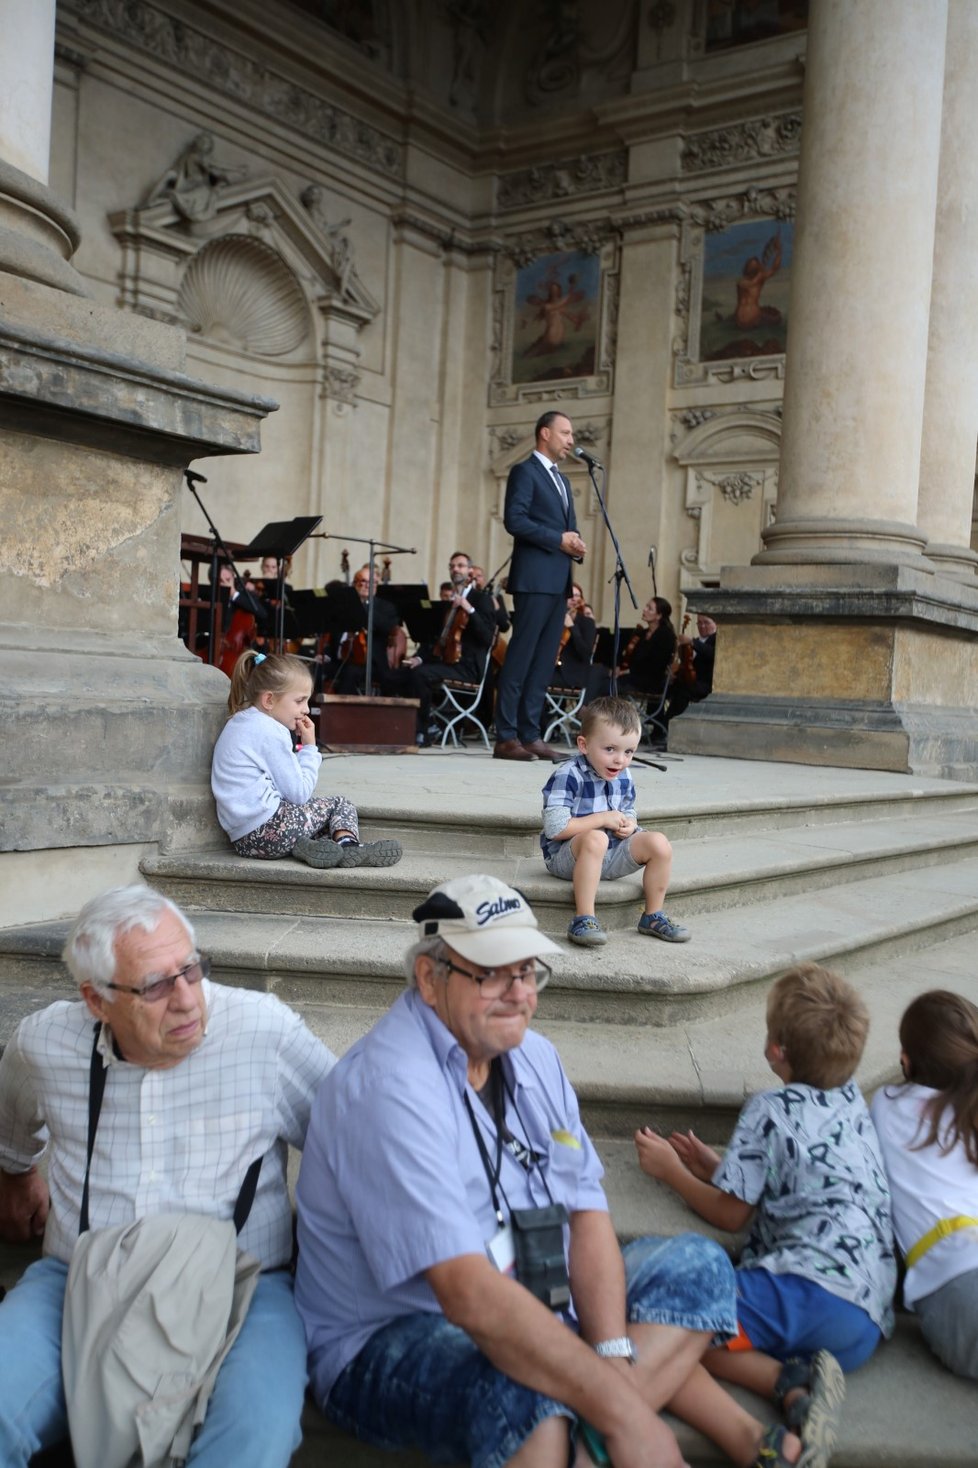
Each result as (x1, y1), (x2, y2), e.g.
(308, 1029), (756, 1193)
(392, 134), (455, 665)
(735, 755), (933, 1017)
(210, 649), (401, 868)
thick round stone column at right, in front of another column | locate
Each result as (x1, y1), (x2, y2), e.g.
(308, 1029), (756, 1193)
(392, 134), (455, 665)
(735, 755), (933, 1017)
(756, 0), (947, 564)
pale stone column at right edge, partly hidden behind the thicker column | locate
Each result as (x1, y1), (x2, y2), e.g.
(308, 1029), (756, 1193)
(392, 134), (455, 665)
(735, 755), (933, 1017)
(918, 0), (978, 581)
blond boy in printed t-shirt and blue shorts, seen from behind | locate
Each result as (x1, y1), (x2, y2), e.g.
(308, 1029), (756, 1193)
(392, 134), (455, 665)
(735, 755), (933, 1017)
(634, 963), (896, 1456)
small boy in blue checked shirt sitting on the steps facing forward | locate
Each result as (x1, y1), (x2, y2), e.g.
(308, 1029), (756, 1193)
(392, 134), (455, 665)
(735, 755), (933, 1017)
(540, 699), (690, 947)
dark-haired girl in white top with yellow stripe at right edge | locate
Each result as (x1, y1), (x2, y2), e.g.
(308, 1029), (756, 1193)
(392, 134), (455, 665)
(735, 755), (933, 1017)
(871, 989), (978, 1380)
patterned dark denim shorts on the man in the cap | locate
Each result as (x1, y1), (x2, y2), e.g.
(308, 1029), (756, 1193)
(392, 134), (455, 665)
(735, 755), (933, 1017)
(325, 1233), (737, 1468)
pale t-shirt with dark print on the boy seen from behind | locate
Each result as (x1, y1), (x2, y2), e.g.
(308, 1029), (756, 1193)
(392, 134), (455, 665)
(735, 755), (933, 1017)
(712, 1080), (896, 1336)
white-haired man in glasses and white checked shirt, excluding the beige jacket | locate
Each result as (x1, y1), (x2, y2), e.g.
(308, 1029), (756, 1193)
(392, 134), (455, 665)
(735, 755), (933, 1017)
(0, 887), (335, 1468)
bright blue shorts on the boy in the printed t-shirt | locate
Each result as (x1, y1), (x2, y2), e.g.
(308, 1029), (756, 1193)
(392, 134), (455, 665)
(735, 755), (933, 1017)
(733, 1268), (883, 1371)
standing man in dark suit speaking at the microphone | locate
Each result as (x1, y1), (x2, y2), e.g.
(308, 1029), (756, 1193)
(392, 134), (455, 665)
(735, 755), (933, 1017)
(493, 411), (587, 759)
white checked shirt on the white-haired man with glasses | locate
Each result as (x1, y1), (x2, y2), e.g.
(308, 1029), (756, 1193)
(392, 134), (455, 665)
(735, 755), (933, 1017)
(0, 979), (336, 1270)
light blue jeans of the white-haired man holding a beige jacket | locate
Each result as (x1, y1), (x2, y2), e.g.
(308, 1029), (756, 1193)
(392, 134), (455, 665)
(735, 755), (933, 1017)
(0, 1260), (305, 1468)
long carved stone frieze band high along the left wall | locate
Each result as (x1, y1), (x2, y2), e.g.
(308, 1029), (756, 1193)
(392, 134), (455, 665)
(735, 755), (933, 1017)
(72, 0), (404, 179)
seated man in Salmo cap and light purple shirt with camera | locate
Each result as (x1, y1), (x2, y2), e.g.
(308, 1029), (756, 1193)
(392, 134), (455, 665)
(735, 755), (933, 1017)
(295, 876), (794, 1468)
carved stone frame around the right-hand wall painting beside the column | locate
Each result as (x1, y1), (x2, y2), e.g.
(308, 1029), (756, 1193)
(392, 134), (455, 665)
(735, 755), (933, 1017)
(673, 188), (794, 388)
